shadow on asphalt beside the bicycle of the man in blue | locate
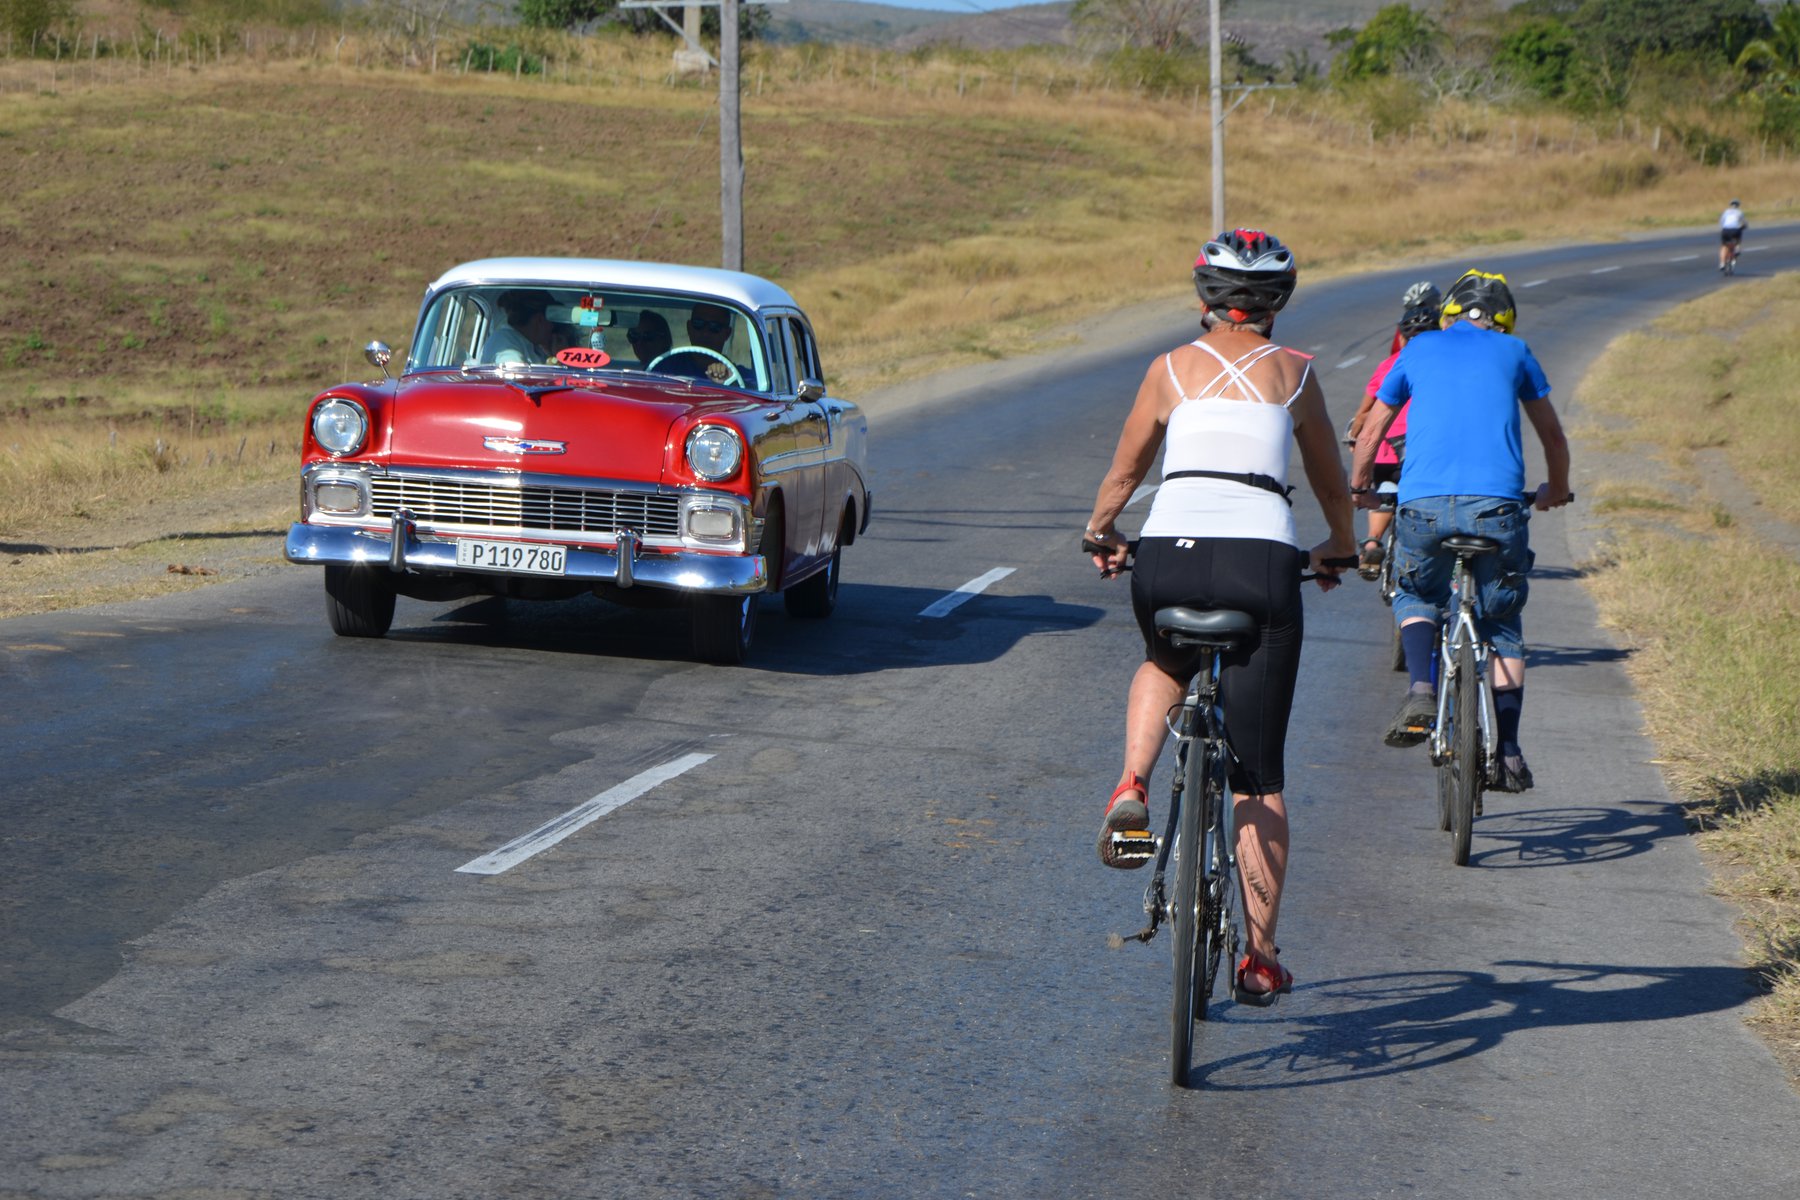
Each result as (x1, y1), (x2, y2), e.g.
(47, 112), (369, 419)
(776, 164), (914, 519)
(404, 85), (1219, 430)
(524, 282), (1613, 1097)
(1469, 793), (1687, 871)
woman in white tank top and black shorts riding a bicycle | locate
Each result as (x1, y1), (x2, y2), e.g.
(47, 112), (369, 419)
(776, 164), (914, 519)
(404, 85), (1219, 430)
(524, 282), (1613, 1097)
(1085, 228), (1355, 1004)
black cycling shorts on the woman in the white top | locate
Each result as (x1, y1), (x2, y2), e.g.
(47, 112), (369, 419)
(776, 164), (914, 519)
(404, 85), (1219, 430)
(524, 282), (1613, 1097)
(1130, 538), (1305, 795)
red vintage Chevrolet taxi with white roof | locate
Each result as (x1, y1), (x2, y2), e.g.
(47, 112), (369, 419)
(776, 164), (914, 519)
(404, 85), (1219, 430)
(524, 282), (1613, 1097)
(286, 257), (869, 662)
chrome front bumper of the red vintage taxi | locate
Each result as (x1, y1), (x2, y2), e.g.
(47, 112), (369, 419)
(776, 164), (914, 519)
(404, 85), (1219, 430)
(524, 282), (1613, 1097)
(286, 522), (769, 594)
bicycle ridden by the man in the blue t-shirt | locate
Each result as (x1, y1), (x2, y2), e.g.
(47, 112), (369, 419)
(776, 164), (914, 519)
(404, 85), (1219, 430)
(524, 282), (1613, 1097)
(1426, 493), (1575, 867)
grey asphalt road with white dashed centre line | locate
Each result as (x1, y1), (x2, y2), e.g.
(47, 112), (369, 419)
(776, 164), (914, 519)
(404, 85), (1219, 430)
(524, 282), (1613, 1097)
(10, 228), (1800, 1200)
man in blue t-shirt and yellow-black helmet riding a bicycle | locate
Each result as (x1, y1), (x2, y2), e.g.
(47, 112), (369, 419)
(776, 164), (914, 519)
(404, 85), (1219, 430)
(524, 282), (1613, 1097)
(1350, 270), (1573, 792)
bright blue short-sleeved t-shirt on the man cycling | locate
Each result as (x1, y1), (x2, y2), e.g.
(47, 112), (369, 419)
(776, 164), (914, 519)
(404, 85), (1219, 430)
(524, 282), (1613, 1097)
(1375, 320), (1550, 504)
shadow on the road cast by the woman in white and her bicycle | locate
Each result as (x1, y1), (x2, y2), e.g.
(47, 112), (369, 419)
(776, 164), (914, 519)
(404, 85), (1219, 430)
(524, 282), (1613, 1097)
(1190, 961), (1755, 1092)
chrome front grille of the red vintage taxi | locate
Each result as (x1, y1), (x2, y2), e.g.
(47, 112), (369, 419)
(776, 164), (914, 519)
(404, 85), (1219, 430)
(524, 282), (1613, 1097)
(369, 475), (680, 538)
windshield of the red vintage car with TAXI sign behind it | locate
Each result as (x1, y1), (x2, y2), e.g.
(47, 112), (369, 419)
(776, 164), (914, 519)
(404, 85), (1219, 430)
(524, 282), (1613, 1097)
(407, 284), (772, 392)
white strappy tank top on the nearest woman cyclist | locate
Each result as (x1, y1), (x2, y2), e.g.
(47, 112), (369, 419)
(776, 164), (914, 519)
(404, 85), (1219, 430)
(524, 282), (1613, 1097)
(1141, 340), (1312, 545)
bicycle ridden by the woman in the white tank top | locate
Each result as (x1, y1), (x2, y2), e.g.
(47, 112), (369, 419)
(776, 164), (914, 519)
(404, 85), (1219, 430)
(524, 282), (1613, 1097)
(1082, 540), (1357, 1087)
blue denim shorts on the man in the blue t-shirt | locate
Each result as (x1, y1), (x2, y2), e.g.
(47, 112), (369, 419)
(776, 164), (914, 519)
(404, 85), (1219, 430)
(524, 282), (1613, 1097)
(1393, 497), (1535, 658)
